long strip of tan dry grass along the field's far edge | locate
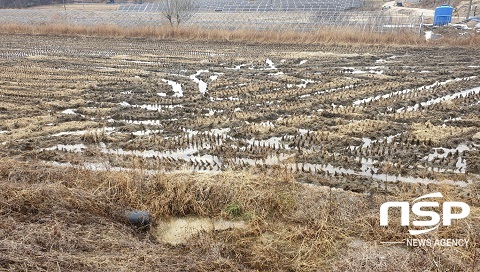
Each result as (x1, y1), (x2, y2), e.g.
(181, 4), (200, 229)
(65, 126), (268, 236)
(0, 24), (424, 45)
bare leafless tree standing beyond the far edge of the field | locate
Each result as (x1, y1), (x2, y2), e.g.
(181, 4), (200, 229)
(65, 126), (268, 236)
(163, 0), (197, 27)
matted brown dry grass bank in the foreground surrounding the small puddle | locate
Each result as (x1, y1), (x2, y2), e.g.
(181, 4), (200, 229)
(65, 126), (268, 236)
(0, 159), (480, 271)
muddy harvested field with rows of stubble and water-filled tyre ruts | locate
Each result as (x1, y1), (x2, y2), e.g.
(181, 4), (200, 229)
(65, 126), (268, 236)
(0, 35), (480, 192)
